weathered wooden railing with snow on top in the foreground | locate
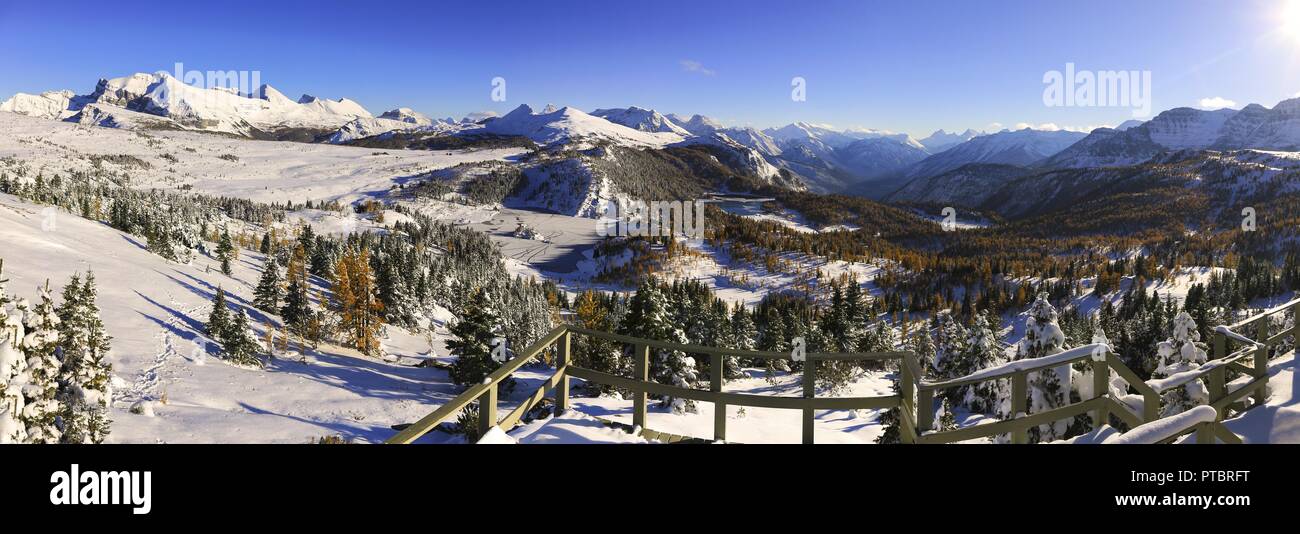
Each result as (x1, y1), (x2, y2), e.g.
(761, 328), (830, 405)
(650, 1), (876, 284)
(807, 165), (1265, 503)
(387, 299), (1300, 443)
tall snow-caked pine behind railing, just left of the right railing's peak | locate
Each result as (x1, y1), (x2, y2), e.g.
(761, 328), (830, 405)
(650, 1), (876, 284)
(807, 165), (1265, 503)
(1009, 292), (1070, 443)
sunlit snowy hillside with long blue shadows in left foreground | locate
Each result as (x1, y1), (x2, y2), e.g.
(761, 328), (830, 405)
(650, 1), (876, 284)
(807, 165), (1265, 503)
(0, 195), (456, 443)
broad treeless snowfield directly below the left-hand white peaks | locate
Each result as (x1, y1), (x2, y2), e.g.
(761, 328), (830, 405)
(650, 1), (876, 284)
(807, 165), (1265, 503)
(0, 113), (523, 203)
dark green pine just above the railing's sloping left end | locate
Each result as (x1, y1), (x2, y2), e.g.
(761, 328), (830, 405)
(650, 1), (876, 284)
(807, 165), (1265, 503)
(447, 288), (515, 391)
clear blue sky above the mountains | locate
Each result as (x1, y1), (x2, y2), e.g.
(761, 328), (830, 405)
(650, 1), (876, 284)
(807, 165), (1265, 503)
(0, 0), (1300, 136)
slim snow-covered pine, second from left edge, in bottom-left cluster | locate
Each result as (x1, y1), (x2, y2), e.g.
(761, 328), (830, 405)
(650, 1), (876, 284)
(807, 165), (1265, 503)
(22, 279), (62, 443)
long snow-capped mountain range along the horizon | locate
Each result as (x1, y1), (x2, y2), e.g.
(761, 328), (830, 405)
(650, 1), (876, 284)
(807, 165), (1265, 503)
(0, 73), (1300, 201)
